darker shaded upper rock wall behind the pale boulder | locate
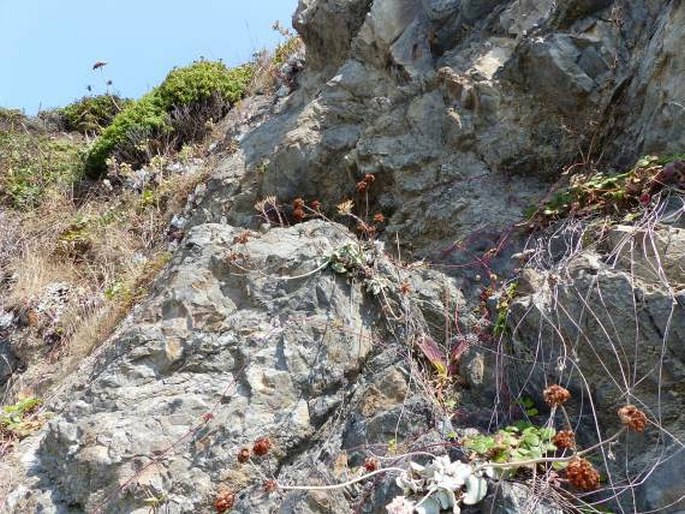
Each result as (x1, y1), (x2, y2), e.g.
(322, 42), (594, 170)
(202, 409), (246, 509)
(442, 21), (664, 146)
(190, 0), (685, 264)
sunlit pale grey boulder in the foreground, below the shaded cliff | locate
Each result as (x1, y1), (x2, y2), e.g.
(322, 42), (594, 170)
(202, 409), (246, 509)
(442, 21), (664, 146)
(2, 221), (463, 513)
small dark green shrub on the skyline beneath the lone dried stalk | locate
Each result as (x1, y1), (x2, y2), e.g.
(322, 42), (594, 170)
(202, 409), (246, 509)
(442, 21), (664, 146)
(58, 95), (131, 134)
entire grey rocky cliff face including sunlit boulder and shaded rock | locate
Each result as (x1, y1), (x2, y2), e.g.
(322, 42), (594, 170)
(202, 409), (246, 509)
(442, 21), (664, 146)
(5, 0), (685, 513)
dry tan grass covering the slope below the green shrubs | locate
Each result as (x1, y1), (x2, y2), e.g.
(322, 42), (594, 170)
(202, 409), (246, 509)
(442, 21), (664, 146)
(0, 122), (212, 404)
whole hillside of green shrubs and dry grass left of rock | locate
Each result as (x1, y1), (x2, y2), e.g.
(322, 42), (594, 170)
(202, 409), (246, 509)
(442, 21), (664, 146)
(0, 38), (299, 420)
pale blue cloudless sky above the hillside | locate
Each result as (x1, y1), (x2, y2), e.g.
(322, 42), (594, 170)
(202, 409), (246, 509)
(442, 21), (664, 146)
(0, 0), (297, 114)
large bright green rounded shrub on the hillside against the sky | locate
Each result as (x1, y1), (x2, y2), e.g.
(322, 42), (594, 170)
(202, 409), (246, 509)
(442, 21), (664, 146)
(86, 60), (253, 178)
